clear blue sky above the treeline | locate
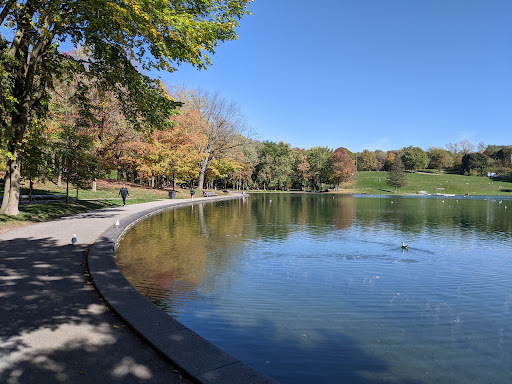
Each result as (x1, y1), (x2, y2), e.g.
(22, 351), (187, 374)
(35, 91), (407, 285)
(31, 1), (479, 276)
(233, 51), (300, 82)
(162, 0), (512, 151)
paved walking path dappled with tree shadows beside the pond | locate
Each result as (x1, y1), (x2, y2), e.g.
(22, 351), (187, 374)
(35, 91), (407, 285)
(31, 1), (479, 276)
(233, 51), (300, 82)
(0, 198), (276, 384)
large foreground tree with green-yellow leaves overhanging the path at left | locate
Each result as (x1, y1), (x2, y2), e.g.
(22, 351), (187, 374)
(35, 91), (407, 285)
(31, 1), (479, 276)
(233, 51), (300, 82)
(0, 0), (251, 215)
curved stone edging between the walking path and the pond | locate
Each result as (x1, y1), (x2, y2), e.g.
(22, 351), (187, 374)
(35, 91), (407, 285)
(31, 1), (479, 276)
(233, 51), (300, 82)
(88, 195), (277, 384)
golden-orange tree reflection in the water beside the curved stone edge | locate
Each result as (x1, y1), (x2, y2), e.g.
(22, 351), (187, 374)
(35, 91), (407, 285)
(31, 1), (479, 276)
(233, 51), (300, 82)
(116, 200), (252, 307)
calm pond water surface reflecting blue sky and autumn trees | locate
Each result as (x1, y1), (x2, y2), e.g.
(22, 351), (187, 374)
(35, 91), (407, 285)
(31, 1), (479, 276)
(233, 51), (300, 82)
(116, 194), (512, 384)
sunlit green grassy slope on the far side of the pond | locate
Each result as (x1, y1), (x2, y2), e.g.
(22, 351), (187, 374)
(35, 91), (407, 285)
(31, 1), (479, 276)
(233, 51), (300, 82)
(345, 172), (512, 196)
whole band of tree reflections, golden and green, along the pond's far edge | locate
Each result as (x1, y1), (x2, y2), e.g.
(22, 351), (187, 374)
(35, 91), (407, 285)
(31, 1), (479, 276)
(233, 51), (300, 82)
(116, 194), (512, 312)
